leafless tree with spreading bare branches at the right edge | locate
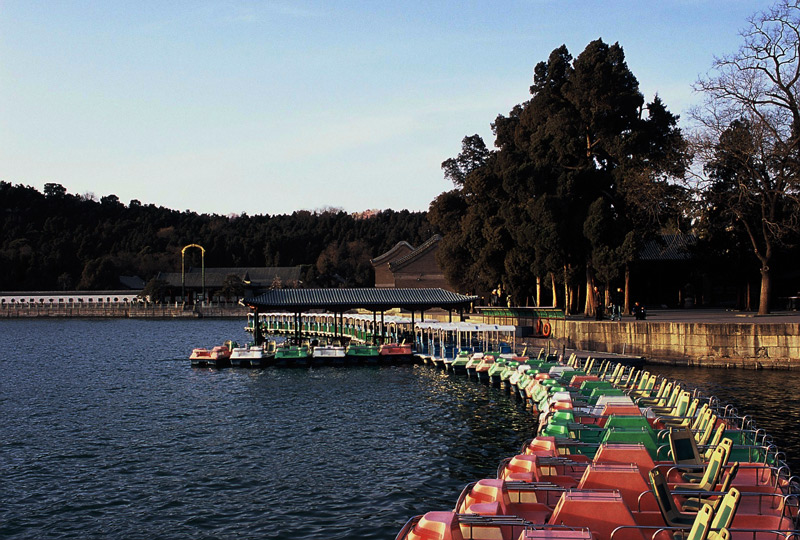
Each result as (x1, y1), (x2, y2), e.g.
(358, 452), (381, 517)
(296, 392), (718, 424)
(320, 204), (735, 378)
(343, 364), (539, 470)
(692, 0), (800, 314)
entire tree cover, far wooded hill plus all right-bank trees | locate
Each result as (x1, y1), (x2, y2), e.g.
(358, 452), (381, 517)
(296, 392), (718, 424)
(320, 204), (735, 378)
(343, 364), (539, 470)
(6, 0), (800, 316)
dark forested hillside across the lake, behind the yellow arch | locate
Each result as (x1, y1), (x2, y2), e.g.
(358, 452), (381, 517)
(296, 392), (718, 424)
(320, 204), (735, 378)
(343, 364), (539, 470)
(0, 182), (433, 291)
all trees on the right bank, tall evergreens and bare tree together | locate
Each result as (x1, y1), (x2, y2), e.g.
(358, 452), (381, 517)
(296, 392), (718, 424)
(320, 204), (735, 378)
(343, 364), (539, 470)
(428, 15), (800, 315)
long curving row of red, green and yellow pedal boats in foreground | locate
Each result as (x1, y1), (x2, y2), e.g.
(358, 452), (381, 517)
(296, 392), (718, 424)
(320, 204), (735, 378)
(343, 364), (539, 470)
(397, 352), (800, 540)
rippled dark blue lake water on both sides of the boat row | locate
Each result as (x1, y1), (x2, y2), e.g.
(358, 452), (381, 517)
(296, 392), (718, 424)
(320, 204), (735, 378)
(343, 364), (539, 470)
(0, 319), (800, 539)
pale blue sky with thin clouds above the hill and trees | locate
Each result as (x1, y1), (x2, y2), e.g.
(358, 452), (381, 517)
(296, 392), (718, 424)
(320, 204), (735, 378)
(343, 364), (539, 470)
(0, 0), (770, 215)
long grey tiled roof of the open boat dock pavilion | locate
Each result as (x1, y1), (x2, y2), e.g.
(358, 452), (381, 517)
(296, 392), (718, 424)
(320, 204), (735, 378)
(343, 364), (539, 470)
(243, 289), (478, 312)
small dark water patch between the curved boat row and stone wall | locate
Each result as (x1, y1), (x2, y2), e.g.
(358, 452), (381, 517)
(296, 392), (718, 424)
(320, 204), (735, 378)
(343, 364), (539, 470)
(648, 365), (800, 474)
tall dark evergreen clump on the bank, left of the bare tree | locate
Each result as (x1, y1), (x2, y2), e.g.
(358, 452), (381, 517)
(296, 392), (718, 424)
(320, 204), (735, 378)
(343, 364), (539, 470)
(429, 40), (690, 315)
